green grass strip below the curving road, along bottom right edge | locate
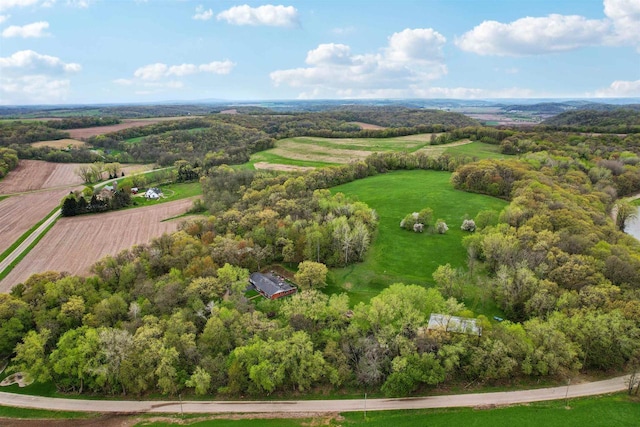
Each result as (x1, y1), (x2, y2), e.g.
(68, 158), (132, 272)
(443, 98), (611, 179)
(129, 394), (640, 427)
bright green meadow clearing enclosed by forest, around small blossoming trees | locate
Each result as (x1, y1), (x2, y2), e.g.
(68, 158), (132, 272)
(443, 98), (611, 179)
(328, 170), (507, 303)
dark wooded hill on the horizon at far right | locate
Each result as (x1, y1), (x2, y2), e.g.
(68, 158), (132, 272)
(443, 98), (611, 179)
(542, 108), (640, 133)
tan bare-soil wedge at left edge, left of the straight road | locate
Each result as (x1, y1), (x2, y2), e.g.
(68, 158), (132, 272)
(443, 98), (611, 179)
(0, 190), (69, 253)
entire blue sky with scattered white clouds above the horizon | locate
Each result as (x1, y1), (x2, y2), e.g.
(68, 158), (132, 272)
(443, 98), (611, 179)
(0, 0), (640, 105)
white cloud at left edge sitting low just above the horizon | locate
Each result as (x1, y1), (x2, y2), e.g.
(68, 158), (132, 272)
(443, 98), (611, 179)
(0, 50), (82, 105)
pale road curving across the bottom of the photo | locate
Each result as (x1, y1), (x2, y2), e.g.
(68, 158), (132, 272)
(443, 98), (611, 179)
(0, 375), (629, 416)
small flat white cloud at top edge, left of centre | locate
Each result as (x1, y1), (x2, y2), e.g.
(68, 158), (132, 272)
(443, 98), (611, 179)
(216, 4), (298, 27)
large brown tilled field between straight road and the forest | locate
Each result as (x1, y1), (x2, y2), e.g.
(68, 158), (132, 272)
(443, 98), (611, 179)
(0, 199), (193, 292)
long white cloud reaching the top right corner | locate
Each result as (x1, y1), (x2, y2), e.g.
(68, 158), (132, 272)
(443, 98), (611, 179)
(456, 0), (640, 56)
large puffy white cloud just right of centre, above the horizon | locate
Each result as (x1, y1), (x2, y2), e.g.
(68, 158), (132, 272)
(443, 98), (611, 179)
(270, 28), (447, 98)
